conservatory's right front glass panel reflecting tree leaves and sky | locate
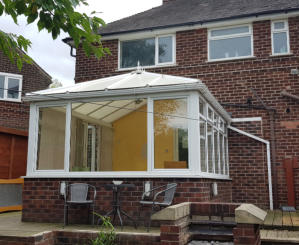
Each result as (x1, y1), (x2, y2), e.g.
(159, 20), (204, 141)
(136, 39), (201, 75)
(154, 99), (188, 169)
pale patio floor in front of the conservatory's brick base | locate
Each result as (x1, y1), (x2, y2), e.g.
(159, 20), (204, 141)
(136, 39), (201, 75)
(0, 212), (160, 237)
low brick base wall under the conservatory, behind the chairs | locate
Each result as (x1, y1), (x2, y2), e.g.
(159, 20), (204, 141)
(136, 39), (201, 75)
(22, 178), (232, 226)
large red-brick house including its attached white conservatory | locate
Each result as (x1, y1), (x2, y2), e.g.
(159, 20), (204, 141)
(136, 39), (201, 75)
(22, 0), (299, 226)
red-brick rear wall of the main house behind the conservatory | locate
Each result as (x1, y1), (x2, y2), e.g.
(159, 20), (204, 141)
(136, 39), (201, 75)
(75, 17), (299, 207)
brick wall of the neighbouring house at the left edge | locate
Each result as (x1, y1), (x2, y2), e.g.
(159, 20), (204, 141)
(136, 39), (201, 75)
(0, 49), (51, 130)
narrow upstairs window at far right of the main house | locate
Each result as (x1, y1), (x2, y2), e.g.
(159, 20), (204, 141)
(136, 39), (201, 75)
(272, 21), (290, 55)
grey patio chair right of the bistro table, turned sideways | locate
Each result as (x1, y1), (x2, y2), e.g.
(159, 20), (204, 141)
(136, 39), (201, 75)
(139, 183), (177, 231)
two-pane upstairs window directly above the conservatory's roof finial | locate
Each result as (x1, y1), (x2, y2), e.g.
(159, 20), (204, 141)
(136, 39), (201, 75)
(119, 35), (175, 68)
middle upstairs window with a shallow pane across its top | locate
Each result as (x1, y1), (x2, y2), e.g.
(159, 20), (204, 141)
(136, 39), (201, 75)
(208, 25), (253, 60)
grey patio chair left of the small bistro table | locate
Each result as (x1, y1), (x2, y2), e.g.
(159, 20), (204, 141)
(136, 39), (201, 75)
(64, 183), (97, 225)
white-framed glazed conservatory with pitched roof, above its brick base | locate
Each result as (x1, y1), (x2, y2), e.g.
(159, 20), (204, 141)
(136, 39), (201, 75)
(24, 69), (231, 179)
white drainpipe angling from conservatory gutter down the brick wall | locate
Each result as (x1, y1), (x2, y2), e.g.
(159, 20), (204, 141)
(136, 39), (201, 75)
(228, 126), (273, 210)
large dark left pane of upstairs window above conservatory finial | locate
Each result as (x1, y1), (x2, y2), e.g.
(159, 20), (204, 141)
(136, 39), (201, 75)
(121, 38), (155, 68)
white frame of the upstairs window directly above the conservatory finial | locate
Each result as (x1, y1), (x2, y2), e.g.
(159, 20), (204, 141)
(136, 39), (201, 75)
(118, 34), (176, 71)
